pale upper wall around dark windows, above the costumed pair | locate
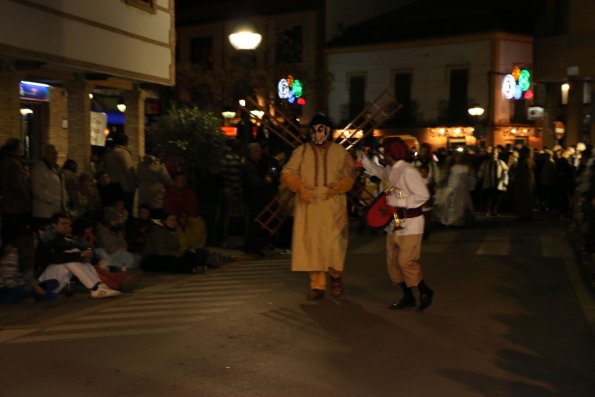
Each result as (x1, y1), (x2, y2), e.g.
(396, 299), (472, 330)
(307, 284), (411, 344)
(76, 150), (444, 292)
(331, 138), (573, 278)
(328, 40), (492, 123)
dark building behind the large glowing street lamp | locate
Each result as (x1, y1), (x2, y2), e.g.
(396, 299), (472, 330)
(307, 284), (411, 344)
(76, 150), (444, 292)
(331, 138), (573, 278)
(177, 1), (328, 133)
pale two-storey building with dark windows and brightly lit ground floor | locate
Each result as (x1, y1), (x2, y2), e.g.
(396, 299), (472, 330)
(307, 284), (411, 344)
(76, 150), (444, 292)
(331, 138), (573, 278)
(327, 1), (542, 147)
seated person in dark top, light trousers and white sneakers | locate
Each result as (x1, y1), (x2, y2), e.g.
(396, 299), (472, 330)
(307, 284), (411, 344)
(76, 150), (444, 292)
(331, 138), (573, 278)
(39, 212), (120, 298)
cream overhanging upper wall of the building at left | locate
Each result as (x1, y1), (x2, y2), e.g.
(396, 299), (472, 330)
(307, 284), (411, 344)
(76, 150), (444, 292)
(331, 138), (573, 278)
(0, 0), (175, 84)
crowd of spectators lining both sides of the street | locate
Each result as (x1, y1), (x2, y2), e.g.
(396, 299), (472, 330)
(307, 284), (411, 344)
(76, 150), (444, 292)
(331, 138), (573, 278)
(0, 125), (595, 302)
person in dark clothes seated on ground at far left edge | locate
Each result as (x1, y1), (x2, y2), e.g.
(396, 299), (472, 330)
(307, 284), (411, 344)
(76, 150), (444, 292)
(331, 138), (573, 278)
(0, 244), (58, 303)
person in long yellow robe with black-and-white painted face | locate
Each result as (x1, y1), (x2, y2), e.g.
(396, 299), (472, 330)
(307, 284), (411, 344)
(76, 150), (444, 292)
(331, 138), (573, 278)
(281, 114), (355, 301)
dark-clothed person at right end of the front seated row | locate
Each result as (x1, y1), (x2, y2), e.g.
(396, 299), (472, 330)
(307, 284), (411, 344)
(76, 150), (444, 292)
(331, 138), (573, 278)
(141, 213), (206, 273)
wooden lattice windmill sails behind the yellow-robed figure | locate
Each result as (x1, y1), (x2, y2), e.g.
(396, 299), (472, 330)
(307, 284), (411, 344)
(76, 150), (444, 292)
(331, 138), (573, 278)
(244, 90), (401, 235)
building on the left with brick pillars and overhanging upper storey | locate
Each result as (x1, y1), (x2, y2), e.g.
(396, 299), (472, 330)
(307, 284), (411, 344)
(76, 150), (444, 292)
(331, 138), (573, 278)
(0, 0), (175, 169)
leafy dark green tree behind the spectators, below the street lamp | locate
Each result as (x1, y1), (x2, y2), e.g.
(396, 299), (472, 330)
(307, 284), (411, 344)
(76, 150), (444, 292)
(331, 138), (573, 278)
(151, 106), (225, 185)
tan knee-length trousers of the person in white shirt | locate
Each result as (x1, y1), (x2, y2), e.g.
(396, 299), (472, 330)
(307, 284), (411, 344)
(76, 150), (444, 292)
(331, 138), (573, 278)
(386, 233), (423, 287)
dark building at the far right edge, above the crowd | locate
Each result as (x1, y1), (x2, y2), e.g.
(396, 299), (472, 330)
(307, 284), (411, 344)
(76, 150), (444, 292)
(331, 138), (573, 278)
(535, 0), (595, 147)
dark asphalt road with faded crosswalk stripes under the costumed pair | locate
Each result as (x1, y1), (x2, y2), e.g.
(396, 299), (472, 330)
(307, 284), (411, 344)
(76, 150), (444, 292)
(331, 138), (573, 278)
(0, 217), (595, 397)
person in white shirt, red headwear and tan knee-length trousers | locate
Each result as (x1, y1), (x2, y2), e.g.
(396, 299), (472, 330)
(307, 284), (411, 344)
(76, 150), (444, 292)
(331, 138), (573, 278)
(357, 138), (434, 311)
